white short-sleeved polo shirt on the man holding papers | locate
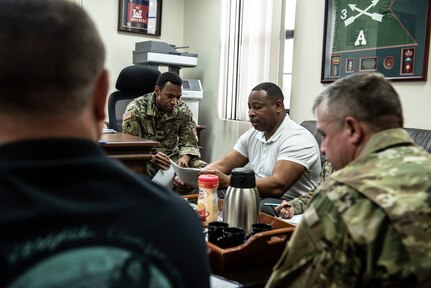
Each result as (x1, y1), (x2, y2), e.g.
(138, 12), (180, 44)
(234, 114), (321, 200)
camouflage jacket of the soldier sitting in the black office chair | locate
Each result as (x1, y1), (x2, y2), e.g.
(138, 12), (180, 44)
(123, 93), (200, 176)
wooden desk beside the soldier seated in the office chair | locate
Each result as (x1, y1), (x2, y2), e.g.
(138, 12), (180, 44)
(100, 133), (160, 175)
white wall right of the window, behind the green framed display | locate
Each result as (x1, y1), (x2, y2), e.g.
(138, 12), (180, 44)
(290, 0), (431, 129)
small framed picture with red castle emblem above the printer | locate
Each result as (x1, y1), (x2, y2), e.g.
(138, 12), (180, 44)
(118, 0), (162, 36)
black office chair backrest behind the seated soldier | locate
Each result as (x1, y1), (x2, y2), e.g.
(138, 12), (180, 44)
(108, 65), (160, 132)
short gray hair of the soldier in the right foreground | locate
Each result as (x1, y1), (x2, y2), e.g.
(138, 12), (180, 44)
(313, 73), (404, 131)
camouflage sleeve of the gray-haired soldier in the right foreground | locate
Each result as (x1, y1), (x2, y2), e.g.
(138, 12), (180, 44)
(266, 181), (414, 287)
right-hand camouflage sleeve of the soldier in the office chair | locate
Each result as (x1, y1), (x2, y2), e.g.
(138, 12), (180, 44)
(178, 103), (201, 157)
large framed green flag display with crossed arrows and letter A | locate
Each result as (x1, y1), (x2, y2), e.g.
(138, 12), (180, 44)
(321, 0), (431, 83)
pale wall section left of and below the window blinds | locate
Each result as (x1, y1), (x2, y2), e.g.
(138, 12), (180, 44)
(182, 0), (251, 162)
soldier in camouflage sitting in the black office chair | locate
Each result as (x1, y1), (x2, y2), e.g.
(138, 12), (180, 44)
(123, 72), (206, 177)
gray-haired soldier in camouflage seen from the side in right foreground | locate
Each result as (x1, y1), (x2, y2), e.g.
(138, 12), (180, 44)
(267, 73), (431, 287)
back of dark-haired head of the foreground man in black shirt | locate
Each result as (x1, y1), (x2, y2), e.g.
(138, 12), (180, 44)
(0, 0), (105, 115)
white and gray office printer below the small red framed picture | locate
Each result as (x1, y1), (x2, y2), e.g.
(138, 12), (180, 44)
(133, 41), (198, 74)
